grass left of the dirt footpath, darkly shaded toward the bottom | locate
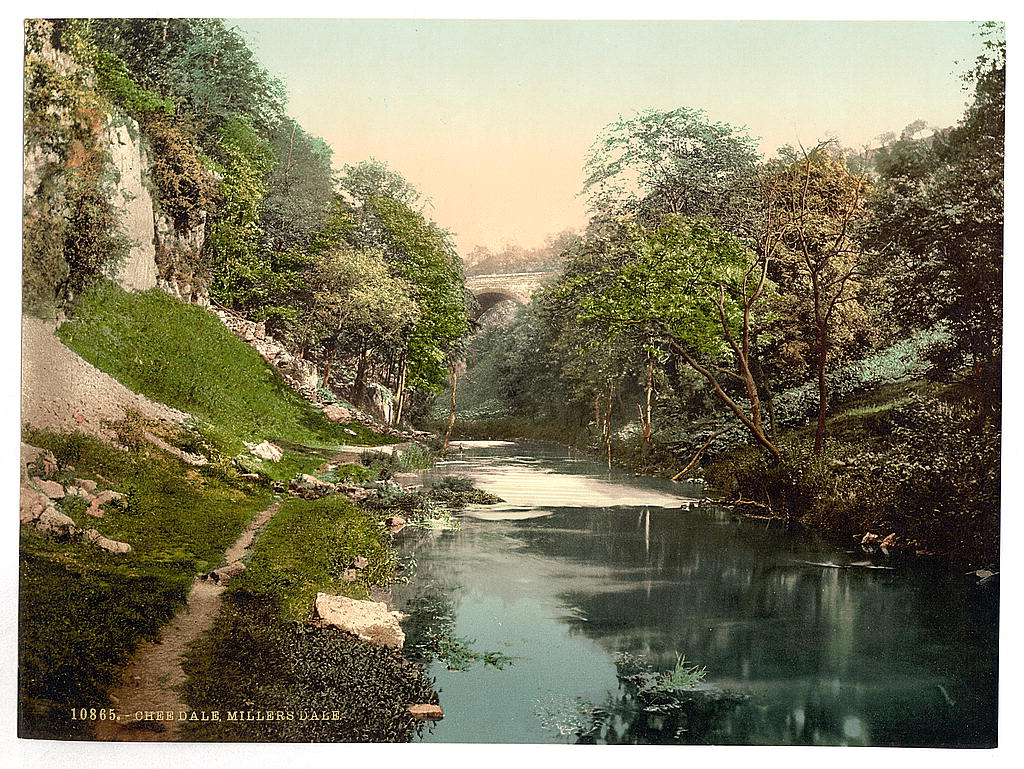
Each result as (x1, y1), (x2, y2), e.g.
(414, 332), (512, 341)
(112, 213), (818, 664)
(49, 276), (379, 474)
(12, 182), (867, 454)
(18, 430), (270, 738)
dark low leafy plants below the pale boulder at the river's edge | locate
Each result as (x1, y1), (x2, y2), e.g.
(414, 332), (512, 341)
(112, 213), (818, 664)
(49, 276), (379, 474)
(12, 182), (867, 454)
(181, 593), (437, 742)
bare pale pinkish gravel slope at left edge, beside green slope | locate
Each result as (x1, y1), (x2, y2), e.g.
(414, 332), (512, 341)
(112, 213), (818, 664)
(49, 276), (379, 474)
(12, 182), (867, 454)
(22, 316), (188, 437)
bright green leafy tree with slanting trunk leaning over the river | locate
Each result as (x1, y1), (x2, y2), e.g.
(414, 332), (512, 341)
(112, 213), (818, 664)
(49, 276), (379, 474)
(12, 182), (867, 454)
(580, 216), (779, 459)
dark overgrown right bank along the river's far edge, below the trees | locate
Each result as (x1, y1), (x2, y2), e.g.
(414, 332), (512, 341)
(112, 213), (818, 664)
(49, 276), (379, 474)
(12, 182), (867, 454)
(436, 381), (999, 570)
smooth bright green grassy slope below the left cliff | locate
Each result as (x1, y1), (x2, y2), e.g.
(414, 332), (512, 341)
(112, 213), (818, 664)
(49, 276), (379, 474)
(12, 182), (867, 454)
(57, 283), (388, 467)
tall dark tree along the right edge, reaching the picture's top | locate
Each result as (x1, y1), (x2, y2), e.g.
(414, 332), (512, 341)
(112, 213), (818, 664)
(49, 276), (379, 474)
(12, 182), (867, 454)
(867, 24), (1006, 418)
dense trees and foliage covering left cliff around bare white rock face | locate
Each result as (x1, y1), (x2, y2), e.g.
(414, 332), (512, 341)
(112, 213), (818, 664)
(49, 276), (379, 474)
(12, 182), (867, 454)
(25, 18), (468, 428)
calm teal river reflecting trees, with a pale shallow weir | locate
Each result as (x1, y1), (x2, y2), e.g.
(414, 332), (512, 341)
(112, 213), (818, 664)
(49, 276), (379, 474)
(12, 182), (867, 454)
(394, 442), (997, 746)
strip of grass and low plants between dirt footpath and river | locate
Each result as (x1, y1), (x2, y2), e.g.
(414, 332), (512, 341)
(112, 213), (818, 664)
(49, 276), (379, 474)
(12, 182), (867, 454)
(178, 497), (436, 741)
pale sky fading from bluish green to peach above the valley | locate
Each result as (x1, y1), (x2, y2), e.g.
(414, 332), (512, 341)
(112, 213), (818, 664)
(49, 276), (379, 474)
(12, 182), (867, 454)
(232, 19), (981, 254)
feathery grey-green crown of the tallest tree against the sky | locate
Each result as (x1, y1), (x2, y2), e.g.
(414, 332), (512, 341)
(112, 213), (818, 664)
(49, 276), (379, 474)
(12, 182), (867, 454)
(584, 108), (758, 227)
